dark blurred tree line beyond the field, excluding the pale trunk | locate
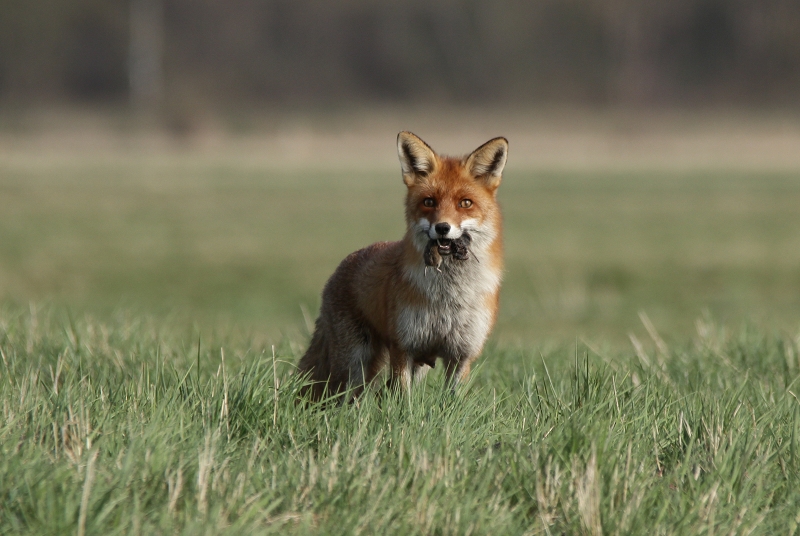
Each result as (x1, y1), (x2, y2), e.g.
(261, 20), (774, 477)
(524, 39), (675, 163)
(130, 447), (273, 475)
(0, 0), (800, 106)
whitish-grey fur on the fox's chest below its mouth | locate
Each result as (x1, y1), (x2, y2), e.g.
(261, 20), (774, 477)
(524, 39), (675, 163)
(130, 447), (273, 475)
(397, 256), (500, 358)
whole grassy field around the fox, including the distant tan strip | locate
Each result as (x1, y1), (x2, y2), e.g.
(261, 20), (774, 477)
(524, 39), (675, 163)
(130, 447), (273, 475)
(0, 111), (800, 534)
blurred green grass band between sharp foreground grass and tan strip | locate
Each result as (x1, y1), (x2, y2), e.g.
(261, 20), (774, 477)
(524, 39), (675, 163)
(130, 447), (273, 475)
(0, 153), (800, 345)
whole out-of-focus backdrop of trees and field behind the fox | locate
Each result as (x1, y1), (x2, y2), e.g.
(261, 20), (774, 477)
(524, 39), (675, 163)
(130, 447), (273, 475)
(0, 0), (800, 348)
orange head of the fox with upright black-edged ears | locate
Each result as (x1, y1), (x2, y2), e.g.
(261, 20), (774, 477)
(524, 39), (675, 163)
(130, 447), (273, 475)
(397, 132), (508, 255)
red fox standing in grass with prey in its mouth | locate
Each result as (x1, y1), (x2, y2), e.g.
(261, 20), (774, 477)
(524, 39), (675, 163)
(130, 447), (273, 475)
(298, 132), (508, 400)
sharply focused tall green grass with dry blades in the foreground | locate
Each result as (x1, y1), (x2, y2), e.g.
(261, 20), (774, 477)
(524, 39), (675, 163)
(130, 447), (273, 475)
(0, 308), (800, 534)
